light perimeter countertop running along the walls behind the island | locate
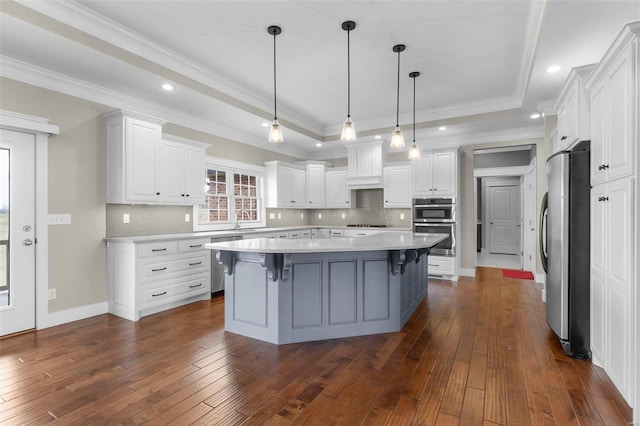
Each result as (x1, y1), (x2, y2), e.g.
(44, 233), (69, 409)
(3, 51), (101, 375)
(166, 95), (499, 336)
(104, 225), (410, 243)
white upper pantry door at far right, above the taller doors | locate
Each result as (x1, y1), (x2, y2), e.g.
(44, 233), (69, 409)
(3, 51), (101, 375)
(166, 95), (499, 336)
(604, 49), (638, 181)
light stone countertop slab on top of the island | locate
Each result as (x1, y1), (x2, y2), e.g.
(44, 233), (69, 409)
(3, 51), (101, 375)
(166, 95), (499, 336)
(205, 231), (448, 253)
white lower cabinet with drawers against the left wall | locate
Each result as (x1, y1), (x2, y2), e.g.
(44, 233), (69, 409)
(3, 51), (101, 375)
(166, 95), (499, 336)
(107, 238), (211, 321)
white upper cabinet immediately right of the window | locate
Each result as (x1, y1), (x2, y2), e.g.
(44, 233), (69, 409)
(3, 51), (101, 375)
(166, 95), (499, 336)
(264, 161), (306, 208)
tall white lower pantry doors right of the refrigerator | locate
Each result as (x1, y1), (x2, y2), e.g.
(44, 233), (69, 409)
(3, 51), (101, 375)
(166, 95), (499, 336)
(590, 179), (638, 404)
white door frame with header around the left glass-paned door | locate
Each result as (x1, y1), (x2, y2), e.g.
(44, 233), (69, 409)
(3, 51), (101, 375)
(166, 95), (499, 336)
(0, 110), (60, 329)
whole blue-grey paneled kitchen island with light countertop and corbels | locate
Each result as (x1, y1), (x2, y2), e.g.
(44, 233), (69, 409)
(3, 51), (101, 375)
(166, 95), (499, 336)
(206, 232), (448, 344)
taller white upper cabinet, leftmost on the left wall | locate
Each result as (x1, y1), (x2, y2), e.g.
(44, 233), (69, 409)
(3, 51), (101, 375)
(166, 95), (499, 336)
(104, 110), (164, 204)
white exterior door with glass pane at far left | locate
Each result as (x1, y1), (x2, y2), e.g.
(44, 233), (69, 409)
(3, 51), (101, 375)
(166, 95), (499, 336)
(0, 129), (36, 335)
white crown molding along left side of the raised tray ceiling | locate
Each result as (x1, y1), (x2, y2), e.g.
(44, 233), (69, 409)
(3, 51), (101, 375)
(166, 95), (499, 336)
(15, 0), (322, 136)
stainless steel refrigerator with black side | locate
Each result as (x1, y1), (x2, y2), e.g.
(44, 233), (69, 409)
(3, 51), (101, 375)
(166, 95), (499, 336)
(540, 141), (591, 359)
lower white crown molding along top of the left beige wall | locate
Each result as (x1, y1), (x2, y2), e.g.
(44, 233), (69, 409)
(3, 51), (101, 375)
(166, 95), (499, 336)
(0, 56), (306, 158)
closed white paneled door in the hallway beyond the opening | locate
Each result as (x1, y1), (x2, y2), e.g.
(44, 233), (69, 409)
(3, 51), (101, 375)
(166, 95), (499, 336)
(488, 185), (520, 255)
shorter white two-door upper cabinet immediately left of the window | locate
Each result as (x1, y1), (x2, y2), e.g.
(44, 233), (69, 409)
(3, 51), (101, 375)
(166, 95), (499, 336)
(160, 140), (205, 205)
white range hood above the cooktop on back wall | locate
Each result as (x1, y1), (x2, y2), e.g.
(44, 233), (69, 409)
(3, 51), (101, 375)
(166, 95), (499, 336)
(347, 139), (386, 189)
